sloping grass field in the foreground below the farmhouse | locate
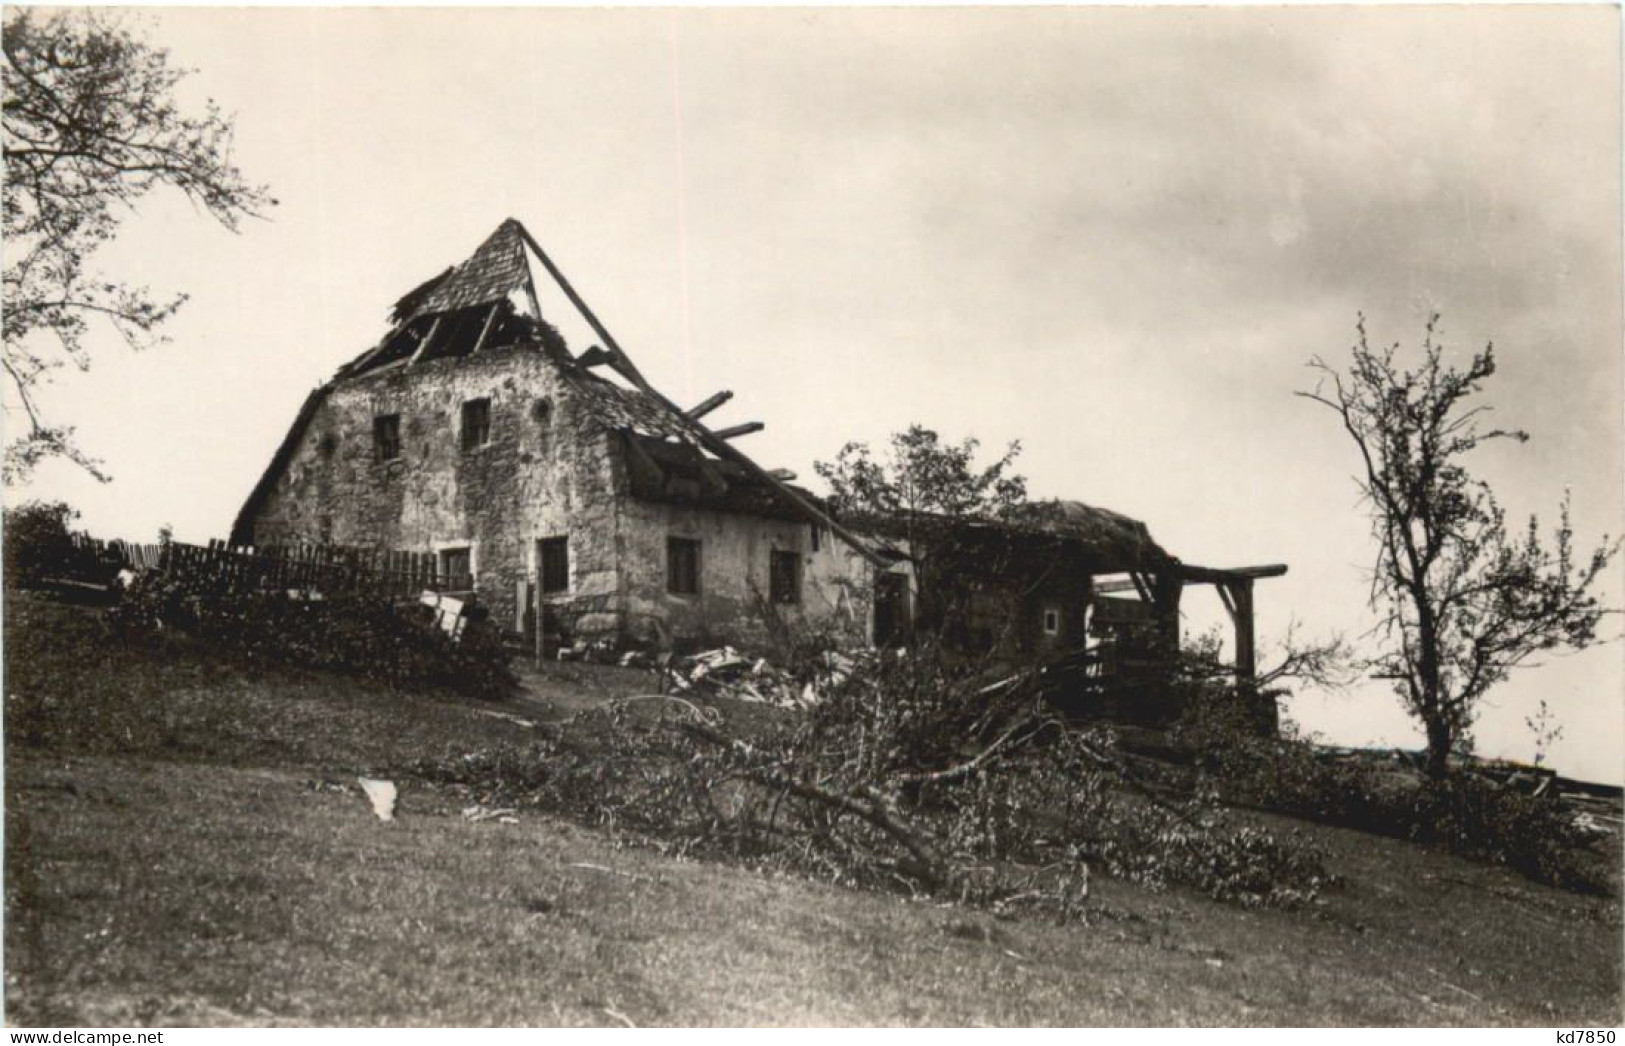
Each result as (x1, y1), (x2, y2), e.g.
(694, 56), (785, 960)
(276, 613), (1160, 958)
(5, 596), (1622, 1027)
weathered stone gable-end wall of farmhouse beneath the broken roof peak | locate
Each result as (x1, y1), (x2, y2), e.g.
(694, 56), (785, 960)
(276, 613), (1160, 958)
(254, 348), (626, 633)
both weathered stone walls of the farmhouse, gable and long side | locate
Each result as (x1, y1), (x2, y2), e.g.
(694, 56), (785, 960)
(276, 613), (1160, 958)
(254, 348), (897, 646)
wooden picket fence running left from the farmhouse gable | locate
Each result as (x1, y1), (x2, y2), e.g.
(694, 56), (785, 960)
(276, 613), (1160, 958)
(73, 534), (475, 596)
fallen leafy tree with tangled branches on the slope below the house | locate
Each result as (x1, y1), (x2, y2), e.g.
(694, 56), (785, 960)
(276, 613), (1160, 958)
(411, 636), (1328, 918)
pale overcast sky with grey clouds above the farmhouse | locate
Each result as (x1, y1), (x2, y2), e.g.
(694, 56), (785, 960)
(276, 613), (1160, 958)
(13, 6), (1625, 781)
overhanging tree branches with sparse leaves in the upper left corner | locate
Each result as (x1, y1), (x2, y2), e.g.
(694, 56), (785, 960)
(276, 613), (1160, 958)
(0, 8), (275, 482)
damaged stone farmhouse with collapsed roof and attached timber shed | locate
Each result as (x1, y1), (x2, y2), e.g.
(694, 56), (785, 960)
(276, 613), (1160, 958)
(232, 219), (1285, 714)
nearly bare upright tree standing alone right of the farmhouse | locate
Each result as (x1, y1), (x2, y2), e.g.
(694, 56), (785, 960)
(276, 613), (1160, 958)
(1297, 317), (1619, 778)
